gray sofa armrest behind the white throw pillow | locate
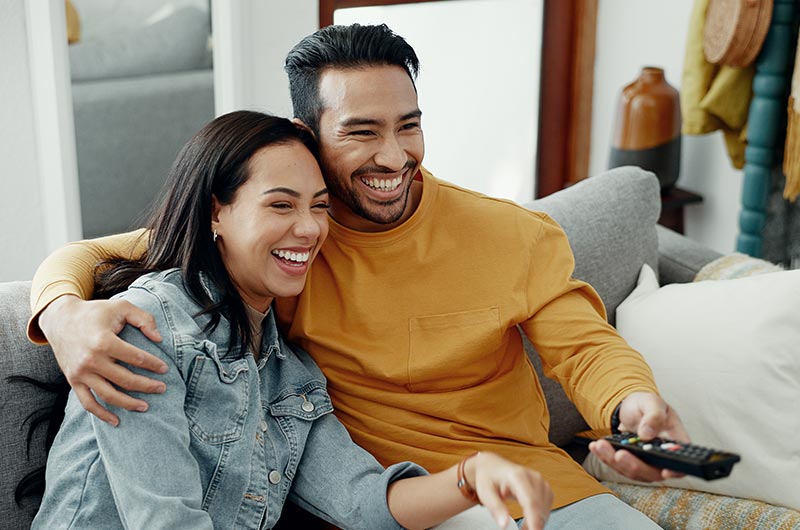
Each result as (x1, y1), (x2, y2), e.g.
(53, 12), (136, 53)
(656, 225), (722, 285)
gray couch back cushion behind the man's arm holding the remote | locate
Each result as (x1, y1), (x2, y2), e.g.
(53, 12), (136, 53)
(525, 167), (661, 445)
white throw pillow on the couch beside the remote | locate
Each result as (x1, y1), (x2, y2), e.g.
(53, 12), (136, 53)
(584, 265), (800, 510)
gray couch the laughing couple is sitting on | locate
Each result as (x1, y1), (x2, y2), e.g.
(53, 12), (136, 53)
(0, 168), (800, 530)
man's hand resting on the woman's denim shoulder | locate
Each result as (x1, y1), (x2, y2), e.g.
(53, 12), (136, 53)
(39, 295), (167, 425)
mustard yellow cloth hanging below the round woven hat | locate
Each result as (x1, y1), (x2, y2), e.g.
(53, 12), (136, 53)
(680, 0), (755, 169)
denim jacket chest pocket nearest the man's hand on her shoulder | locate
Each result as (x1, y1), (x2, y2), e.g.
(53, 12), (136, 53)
(184, 341), (249, 444)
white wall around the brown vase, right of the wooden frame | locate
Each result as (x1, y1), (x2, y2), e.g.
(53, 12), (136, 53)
(589, 0), (742, 253)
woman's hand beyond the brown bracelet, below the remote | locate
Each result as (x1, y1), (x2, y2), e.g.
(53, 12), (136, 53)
(464, 451), (553, 530)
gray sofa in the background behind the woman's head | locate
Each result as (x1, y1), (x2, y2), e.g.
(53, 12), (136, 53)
(69, 0), (214, 238)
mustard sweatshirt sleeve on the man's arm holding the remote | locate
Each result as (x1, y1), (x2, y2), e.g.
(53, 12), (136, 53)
(521, 212), (658, 429)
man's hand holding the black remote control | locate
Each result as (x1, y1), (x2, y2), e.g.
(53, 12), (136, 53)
(589, 392), (690, 482)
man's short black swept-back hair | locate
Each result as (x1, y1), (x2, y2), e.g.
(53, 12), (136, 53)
(284, 24), (419, 135)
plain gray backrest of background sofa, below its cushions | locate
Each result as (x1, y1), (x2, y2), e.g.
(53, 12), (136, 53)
(72, 70), (214, 238)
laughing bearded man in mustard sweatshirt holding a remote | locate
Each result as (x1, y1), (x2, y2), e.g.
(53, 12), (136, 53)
(31, 25), (687, 529)
